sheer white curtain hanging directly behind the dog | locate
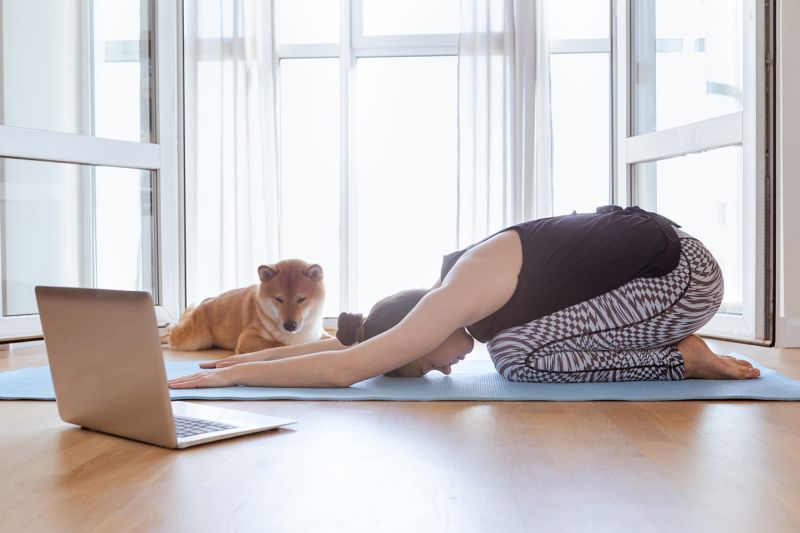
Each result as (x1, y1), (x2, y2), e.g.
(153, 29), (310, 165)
(184, 0), (280, 303)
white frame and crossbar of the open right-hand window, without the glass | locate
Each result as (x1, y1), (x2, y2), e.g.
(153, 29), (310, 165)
(613, 0), (774, 344)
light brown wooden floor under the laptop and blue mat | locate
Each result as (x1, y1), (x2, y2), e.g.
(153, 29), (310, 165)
(0, 343), (800, 533)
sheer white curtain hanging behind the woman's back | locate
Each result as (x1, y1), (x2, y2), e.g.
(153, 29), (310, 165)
(458, 0), (552, 246)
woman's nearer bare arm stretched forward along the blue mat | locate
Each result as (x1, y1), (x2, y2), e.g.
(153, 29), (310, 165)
(170, 231), (522, 388)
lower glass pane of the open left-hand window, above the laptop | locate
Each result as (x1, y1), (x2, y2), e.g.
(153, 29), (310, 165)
(0, 158), (153, 316)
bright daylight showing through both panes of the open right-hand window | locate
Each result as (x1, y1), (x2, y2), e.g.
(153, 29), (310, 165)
(632, 0), (754, 326)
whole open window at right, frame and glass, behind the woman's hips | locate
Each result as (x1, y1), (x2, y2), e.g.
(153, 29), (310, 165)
(619, 0), (772, 342)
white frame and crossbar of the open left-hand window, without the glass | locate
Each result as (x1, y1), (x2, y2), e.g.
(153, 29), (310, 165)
(0, 0), (183, 342)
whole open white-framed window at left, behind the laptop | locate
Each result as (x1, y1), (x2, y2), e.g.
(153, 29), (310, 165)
(0, 0), (179, 340)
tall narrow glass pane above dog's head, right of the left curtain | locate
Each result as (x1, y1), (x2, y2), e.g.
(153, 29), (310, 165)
(280, 59), (341, 316)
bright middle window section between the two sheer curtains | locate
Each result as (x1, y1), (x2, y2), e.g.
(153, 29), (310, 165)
(275, 0), (459, 316)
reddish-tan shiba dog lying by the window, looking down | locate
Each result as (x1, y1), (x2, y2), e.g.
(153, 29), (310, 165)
(162, 259), (328, 353)
